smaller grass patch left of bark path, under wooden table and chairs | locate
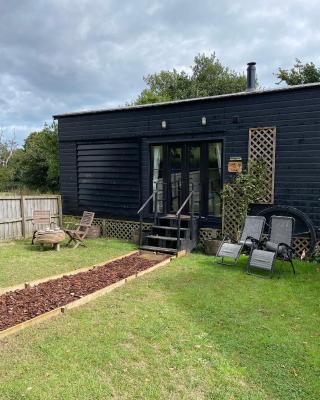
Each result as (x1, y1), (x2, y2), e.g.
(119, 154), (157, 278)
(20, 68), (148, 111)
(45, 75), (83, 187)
(0, 239), (135, 288)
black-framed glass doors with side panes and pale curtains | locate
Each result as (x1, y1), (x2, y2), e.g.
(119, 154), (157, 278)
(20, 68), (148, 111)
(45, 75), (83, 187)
(152, 142), (222, 217)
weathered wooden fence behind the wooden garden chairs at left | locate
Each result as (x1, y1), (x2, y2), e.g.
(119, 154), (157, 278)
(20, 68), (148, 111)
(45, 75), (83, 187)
(0, 196), (62, 240)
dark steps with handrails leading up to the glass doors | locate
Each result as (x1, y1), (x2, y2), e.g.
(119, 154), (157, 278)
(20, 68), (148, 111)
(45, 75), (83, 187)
(138, 180), (198, 254)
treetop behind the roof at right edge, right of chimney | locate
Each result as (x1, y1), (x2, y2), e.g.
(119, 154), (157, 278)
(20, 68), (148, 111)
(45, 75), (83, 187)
(276, 58), (320, 86)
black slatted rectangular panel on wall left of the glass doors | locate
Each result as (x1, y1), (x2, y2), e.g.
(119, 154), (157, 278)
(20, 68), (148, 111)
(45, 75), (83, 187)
(77, 142), (140, 217)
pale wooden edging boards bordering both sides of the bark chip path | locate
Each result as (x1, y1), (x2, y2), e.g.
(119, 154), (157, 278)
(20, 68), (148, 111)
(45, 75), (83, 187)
(0, 251), (174, 340)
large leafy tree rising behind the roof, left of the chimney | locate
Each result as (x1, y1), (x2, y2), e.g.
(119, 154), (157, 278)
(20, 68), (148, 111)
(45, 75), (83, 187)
(135, 53), (246, 104)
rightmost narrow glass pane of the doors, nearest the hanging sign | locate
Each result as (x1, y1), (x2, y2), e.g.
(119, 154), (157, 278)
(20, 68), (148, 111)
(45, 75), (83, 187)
(208, 143), (222, 217)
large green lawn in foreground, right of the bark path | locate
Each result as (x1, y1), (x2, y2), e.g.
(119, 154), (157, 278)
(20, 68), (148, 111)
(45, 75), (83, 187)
(0, 242), (320, 400)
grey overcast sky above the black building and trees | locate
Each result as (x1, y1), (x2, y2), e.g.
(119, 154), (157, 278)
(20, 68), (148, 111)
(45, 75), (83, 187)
(0, 0), (320, 142)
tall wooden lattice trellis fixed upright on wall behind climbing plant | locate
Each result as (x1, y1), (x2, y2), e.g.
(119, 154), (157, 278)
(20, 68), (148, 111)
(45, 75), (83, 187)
(249, 127), (276, 204)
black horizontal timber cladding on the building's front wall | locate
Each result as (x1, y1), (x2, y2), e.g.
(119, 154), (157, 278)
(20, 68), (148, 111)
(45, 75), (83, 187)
(59, 87), (320, 225)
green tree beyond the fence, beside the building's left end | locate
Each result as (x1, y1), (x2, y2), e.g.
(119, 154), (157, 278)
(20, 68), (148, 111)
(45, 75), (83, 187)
(12, 123), (59, 191)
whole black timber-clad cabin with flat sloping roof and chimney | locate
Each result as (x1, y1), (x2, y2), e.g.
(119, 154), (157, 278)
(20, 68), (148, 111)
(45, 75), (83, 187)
(54, 63), (320, 255)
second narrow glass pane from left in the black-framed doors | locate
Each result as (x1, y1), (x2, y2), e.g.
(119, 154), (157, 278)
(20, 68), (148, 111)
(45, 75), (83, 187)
(169, 146), (182, 212)
